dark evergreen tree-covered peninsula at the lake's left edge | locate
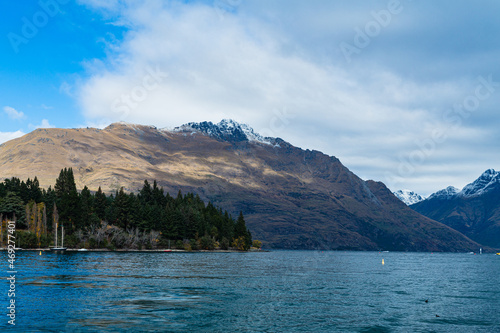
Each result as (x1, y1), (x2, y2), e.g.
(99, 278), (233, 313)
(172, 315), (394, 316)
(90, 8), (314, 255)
(0, 168), (254, 250)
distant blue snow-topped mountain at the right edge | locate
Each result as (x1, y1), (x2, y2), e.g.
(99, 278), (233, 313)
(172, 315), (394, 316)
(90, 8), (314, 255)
(411, 169), (500, 248)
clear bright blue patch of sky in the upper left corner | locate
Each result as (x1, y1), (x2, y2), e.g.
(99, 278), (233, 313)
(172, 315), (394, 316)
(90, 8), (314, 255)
(0, 1), (126, 133)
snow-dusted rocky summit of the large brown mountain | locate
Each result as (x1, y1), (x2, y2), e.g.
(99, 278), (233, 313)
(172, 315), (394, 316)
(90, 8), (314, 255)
(173, 119), (276, 145)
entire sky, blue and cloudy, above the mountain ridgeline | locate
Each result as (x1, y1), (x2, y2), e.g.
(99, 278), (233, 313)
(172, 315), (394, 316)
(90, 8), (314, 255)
(0, 0), (500, 196)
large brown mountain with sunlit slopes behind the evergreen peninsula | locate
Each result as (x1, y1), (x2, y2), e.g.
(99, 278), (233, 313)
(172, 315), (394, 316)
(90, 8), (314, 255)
(0, 120), (478, 251)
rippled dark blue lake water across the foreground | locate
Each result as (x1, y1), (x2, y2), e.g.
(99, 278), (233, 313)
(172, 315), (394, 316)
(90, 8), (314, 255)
(0, 251), (500, 333)
